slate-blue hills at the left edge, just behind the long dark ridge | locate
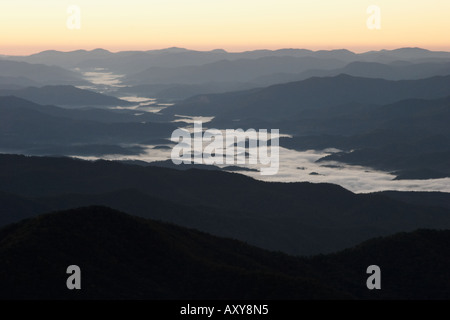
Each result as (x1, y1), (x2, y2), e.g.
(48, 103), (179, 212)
(0, 96), (176, 156)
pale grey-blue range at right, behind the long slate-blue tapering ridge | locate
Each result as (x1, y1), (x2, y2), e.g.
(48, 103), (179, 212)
(110, 56), (450, 100)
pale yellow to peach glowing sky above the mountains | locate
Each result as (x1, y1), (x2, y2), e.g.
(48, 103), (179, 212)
(0, 0), (450, 55)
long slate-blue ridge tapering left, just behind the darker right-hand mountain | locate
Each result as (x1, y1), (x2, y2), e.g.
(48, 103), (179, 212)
(163, 74), (450, 121)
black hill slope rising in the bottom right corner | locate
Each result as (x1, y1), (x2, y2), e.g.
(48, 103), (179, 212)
(313, 230), (450, 300)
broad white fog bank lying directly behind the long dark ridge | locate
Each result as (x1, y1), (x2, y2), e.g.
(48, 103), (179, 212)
(82, 142), (450, 193)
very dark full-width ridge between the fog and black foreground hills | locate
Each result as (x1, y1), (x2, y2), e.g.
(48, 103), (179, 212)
(0, 155), (450, 254)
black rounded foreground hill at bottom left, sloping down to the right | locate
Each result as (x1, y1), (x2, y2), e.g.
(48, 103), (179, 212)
(0, 207), (345, 299)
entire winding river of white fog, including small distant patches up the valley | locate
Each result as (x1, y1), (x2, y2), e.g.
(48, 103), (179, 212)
(75, 70), (450, 193)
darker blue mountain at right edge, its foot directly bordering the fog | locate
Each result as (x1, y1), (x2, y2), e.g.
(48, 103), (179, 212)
(278, 97), (450, 179)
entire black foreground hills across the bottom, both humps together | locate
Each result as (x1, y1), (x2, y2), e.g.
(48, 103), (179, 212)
(0, 207), (450, 300)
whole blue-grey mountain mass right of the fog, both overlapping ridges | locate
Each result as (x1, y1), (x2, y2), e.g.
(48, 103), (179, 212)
(163, 75), (450, 179)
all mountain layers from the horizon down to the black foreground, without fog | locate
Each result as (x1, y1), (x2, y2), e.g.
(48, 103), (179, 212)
(0, 48), (450, 300)
